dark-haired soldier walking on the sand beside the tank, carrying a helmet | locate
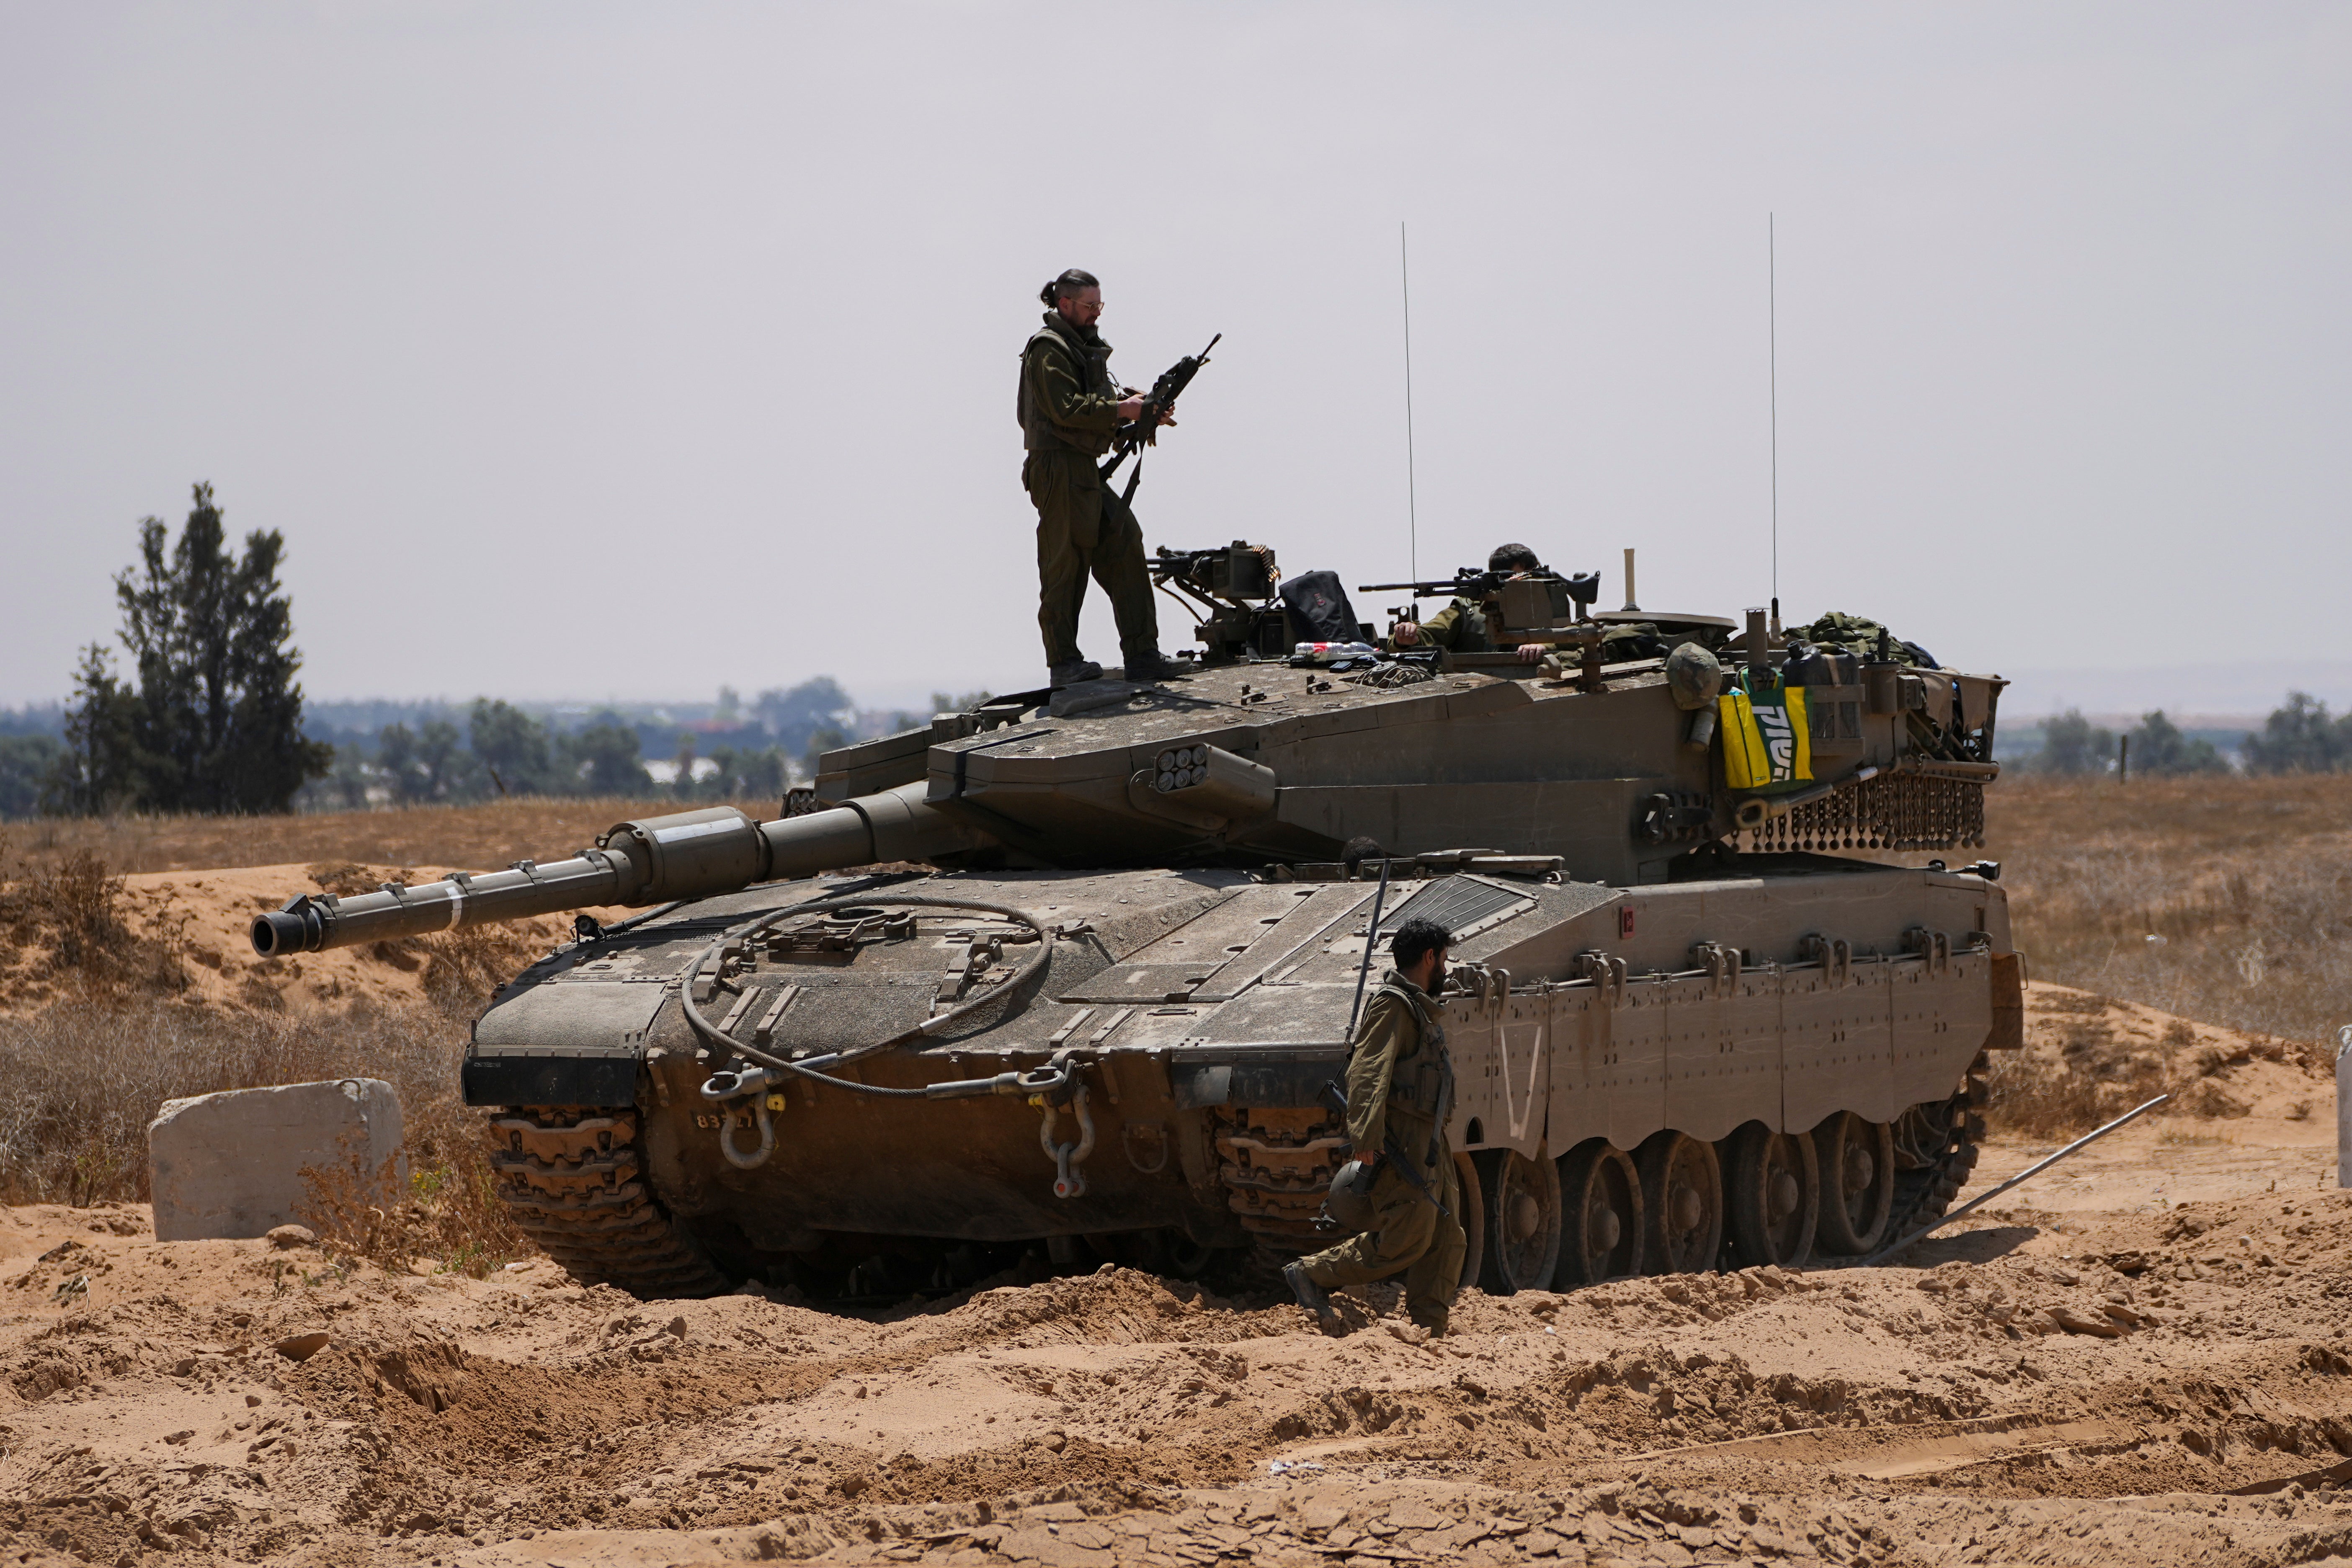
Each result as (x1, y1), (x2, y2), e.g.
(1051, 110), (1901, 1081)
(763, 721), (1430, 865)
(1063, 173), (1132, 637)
(1282, 919), (1470, 1335)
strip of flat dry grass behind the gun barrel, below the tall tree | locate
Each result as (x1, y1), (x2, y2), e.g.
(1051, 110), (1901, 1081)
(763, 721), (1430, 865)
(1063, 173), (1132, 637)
(12, 797), (689, 874)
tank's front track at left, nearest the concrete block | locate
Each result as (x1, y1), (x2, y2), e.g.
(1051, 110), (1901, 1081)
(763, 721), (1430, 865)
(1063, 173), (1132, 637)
(489, 1105), (732, 1297)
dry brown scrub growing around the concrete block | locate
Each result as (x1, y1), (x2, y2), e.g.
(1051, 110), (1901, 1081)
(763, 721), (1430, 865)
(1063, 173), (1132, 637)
(0, 999), (529, 1272)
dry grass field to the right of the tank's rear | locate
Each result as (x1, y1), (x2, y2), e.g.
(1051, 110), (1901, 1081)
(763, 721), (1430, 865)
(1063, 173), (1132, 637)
(1985, 774), (2352, 1042)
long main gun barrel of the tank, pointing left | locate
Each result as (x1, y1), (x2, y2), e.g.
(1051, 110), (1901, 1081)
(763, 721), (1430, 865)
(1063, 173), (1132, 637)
(252, 783), (990, 959)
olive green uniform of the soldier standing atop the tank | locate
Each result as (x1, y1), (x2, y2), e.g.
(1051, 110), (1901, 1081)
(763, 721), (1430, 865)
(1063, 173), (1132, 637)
(1021, 310), (1160, 668)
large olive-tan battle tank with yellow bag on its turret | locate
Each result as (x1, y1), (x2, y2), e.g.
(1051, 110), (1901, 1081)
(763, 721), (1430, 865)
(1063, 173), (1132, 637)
(254, 543), (2023, 1297)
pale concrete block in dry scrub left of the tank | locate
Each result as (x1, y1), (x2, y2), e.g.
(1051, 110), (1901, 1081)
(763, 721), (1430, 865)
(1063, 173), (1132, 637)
(148, 1079), (407, 1241)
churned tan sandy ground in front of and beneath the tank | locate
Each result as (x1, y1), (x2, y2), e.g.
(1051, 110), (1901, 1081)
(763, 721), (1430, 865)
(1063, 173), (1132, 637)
(0, 990), (2352, 1568)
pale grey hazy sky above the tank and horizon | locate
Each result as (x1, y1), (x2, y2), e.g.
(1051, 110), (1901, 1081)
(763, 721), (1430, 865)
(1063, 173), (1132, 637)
(0, 0), (2352, 703)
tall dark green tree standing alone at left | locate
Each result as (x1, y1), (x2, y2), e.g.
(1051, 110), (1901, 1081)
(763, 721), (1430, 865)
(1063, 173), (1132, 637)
(59, 484), (334, 811)
